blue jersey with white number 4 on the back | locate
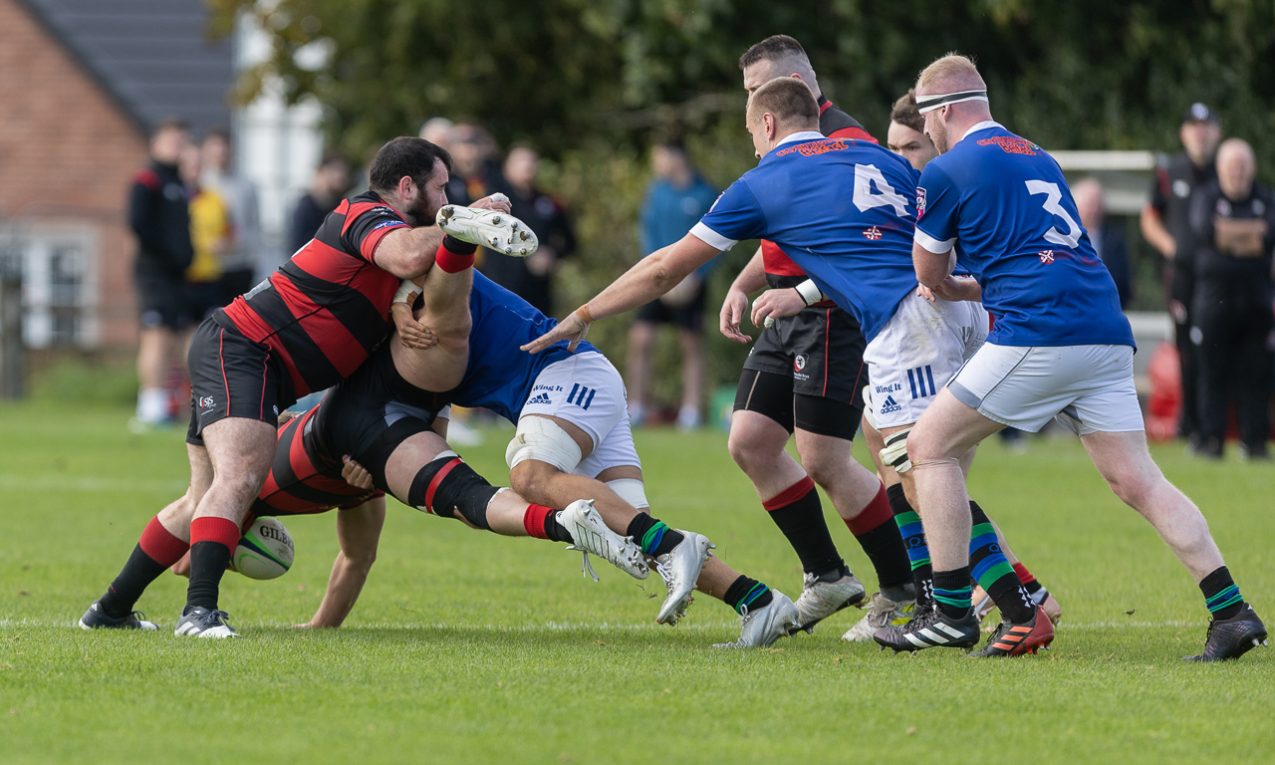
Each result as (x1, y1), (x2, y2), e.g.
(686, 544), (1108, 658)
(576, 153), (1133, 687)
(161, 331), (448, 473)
(691, 131), (917, 340)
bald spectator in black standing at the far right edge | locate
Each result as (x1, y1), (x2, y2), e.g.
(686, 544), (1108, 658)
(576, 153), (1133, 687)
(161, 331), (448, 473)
(1190, 138), (1275, 459)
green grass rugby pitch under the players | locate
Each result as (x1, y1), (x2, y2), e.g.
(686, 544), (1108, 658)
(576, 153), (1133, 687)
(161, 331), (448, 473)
(0, 405), (1275, 765)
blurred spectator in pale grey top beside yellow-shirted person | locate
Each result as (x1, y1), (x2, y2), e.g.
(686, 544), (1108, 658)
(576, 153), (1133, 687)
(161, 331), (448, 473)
(199, 129), (258, 306)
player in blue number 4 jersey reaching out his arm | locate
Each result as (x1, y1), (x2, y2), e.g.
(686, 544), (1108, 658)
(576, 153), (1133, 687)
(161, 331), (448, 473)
(527, 78), (1048, 650)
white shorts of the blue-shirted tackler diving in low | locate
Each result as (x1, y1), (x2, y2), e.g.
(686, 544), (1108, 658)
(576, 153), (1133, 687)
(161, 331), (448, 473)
(519, 351), (641, 478)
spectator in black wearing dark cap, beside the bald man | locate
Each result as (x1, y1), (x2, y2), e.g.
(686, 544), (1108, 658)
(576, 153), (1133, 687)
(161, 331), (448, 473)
(1140, 103), (1221, 448)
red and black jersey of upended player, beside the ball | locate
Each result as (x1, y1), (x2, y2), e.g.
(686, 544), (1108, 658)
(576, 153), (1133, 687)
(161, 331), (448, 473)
(251, 407), (384, 515)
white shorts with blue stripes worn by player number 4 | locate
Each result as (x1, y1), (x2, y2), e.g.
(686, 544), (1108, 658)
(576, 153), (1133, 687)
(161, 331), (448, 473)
(863, 292), (987, 430)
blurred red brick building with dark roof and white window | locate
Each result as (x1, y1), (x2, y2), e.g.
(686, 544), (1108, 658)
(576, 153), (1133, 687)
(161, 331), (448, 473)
(0, 0), (233, 349)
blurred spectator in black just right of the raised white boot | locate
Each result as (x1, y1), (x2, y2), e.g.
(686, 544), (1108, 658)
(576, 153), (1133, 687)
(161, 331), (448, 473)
(482, 145), (575, 316)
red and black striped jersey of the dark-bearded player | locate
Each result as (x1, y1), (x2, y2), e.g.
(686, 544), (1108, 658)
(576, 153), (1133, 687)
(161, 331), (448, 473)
(214, 191), (409, 397)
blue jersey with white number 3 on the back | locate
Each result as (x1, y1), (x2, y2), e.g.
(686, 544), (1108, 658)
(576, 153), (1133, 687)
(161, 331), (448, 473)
(917, 122), (1133, 346)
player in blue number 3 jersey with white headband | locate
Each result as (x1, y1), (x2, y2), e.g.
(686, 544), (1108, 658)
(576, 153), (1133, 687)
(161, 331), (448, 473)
(876, 55), (1266, 660)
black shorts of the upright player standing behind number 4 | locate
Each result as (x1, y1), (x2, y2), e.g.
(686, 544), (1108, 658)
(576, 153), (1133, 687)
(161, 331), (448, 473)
(734, 306), (867, 439)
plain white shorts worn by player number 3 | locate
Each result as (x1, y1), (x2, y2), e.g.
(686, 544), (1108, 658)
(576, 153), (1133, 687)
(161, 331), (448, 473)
(947, 343), (1144, 436)
